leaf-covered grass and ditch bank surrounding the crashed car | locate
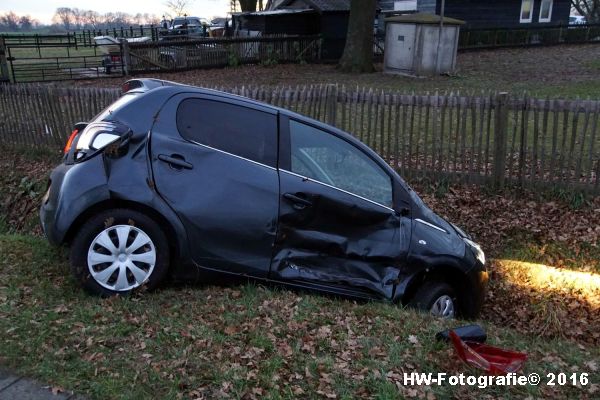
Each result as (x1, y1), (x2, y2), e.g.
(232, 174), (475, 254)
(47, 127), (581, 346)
(0, 149), (600, 399)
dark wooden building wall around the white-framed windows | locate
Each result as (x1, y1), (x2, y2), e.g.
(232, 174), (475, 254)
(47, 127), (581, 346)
(438, 0), (571, 28)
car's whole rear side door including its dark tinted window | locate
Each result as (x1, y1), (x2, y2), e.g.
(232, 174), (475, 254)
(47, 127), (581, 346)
(151, 94), (279, 278)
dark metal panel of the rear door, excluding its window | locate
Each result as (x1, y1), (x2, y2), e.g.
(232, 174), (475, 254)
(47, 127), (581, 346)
(151, 95), (279, 278)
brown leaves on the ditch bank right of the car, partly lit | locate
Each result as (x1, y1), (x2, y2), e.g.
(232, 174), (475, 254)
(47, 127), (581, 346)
(423, 187), (600, 344)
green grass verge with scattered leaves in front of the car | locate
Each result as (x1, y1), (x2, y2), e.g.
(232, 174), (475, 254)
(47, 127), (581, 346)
(0, 235), (600, 399)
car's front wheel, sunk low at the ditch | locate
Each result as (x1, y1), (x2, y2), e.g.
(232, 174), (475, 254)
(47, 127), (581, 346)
(408, 282), (459, 319)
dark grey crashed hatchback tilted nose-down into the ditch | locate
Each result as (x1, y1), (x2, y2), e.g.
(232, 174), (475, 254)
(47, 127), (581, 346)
(41, 79), (488, 318)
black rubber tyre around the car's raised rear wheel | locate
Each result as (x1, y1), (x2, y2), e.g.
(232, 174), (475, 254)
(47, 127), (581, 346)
(70, 209), (169, 297)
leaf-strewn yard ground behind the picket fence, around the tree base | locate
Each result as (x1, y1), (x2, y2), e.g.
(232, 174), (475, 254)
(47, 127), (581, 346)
(69, 44), (600, 97)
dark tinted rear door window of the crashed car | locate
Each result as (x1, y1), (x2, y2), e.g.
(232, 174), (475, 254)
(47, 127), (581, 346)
(177, 99), (277, 167)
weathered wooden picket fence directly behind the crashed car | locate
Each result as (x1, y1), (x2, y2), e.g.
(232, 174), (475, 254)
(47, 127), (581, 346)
(0, 84), (600, 194)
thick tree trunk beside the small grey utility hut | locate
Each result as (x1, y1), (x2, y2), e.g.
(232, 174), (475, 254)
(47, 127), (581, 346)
(339, 0), (376, 73)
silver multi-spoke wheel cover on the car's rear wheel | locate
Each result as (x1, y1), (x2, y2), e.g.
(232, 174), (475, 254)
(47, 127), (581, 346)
(87, 225), (156, 292)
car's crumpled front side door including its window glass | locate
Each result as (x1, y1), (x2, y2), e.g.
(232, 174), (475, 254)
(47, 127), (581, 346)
(271, 115), (410, 298)
